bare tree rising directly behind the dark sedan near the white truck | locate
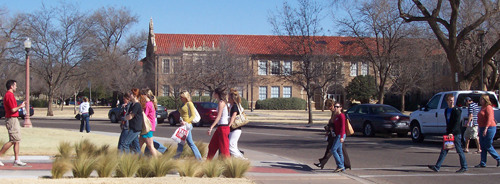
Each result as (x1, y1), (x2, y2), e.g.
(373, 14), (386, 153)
(337, 0), (409, 104)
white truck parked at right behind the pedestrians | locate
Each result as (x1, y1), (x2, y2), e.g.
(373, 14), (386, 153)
(410, 91), (500, 142)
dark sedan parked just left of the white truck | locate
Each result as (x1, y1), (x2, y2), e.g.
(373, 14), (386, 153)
(346, 104), (410, 137)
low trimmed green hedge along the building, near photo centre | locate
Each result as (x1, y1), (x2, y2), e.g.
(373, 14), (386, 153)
(255, 97), (307, 110)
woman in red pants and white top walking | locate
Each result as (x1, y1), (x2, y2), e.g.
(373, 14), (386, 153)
(207, 88), (231, 160)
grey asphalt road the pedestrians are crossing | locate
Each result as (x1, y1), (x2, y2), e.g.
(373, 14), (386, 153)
(32, 119), (500, 183)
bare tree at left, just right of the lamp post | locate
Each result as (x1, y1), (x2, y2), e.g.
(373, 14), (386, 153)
(21, 3), (92, 116)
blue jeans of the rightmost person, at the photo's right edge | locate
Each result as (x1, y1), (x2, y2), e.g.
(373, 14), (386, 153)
(479, 126), (500, 166)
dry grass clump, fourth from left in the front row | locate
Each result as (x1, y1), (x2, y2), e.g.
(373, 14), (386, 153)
(116, 154), (141, 177)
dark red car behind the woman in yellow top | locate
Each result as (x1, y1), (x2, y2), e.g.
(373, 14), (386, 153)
(168, 102), (217, 126)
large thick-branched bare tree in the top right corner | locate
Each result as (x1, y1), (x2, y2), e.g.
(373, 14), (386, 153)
(398, 0), (500, 90)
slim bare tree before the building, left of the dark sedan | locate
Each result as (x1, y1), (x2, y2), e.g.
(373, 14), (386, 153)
(269, 0), (324, 124)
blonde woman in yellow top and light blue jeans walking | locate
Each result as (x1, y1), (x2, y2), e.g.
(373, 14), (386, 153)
(177, 91), (201, 161)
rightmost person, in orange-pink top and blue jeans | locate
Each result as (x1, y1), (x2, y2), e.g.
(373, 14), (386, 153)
(474, 95), (500, 167)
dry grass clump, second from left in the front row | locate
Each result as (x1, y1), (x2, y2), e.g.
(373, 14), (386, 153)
(72, 152), (97, 178)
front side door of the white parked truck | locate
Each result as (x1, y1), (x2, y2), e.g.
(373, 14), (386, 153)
(419, 94), (443, 133)
